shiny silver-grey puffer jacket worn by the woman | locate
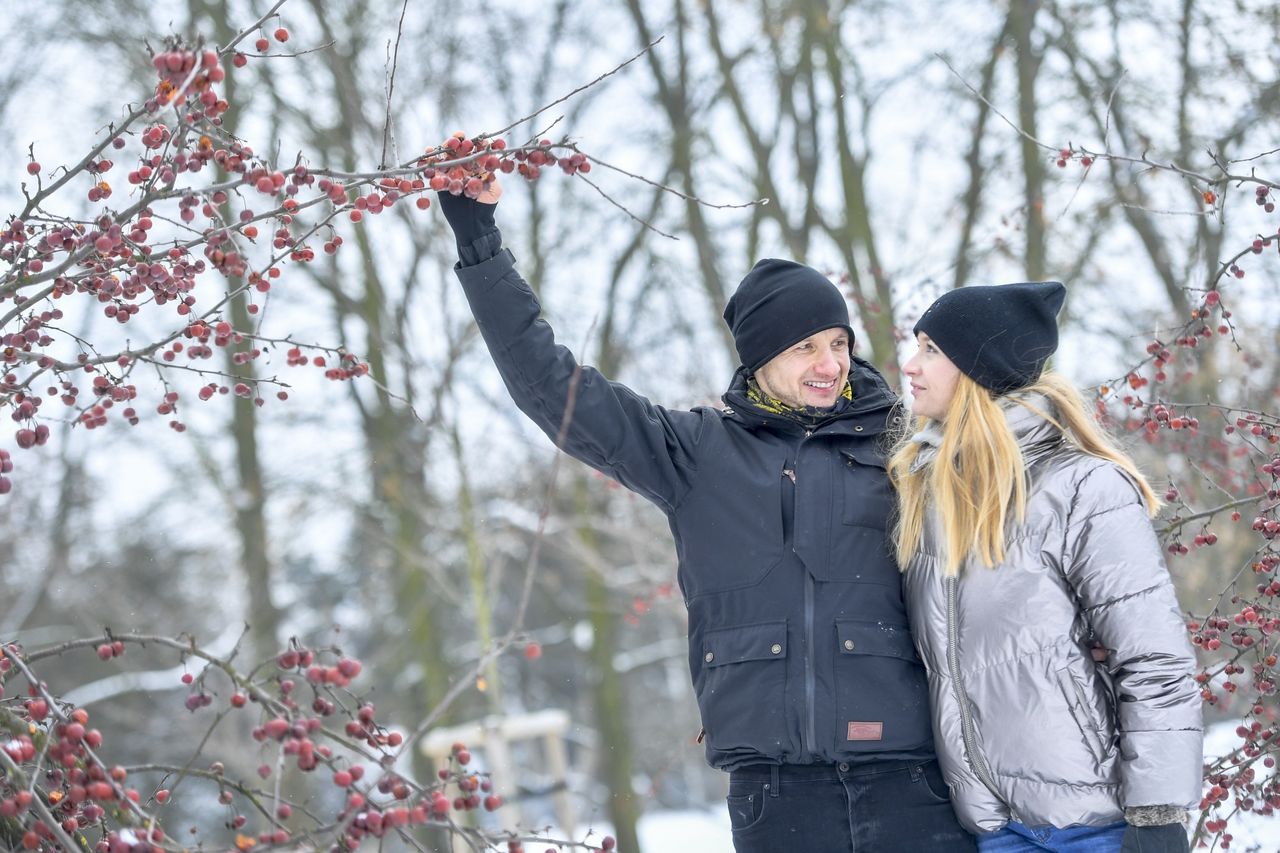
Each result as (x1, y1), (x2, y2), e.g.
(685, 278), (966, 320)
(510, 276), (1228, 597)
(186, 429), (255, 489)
(904, 396), (1202, 833)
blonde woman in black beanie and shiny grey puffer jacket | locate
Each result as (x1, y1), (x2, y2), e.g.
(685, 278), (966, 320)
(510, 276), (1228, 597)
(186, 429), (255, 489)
(888, 282), (1202, 853)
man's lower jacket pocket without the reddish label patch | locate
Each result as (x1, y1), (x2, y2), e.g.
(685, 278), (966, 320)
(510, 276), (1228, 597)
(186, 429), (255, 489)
(695, 621), (788, 757)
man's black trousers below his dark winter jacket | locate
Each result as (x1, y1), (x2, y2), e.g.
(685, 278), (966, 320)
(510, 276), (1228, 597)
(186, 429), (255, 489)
(728, 761), (977, 853)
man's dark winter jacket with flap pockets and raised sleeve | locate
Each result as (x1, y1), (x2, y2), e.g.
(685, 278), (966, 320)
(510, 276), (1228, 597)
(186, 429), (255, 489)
(457, 250), (933, 770)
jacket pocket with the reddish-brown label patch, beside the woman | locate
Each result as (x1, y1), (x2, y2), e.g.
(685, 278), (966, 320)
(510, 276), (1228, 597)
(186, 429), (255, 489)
(835, 620), (932, 753)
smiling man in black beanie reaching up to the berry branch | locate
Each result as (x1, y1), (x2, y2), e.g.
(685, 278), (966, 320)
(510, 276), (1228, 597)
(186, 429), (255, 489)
(440, 185), (974, 853)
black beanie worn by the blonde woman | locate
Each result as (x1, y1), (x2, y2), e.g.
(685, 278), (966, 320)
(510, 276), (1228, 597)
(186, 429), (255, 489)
(913, 282), (1066, 394)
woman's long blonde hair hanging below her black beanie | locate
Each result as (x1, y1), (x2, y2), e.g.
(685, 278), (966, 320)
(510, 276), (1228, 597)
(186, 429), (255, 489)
(887, 371), (1160, 575)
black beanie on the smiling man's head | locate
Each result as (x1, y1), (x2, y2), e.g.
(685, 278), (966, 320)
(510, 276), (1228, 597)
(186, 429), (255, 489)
(724, 257), (854, 373)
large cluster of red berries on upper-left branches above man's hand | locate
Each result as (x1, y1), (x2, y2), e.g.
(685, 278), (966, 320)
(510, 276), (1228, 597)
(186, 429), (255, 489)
(0, 51), (591, 494)
